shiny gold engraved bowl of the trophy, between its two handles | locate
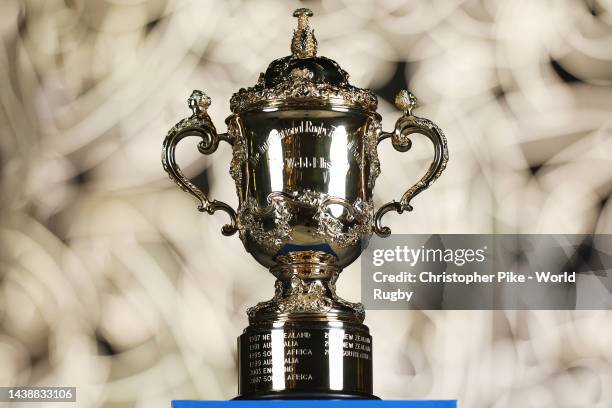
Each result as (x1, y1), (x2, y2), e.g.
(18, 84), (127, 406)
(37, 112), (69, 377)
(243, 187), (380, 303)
(230, 109), (380, 267)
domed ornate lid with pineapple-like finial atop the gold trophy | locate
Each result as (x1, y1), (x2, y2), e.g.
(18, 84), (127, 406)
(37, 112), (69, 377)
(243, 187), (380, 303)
(230, 8), (378, 113)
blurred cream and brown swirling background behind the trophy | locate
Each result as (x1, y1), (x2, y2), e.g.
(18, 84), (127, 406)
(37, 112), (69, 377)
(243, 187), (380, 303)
(0, 0), (612, 408)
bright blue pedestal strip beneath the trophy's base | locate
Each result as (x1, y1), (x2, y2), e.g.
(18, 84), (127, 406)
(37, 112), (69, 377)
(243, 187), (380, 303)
(172, 400), (457, 408)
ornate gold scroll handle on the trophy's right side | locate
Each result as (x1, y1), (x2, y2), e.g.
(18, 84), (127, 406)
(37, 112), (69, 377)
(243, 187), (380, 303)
(374, 90), (448, 237)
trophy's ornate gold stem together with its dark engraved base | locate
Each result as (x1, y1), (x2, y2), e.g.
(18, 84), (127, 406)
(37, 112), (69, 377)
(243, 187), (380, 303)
(238, 251), (376, 399)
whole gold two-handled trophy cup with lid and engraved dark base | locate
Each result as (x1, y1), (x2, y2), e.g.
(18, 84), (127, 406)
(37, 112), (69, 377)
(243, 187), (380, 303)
(162, 9), (448, 399)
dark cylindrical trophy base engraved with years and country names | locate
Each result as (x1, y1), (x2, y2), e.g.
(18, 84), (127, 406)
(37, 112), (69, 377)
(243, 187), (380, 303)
(236, 319), (378, 399)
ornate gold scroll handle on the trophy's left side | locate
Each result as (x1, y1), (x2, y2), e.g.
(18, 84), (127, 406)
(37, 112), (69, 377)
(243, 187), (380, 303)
(162, 91), (238, 236)
